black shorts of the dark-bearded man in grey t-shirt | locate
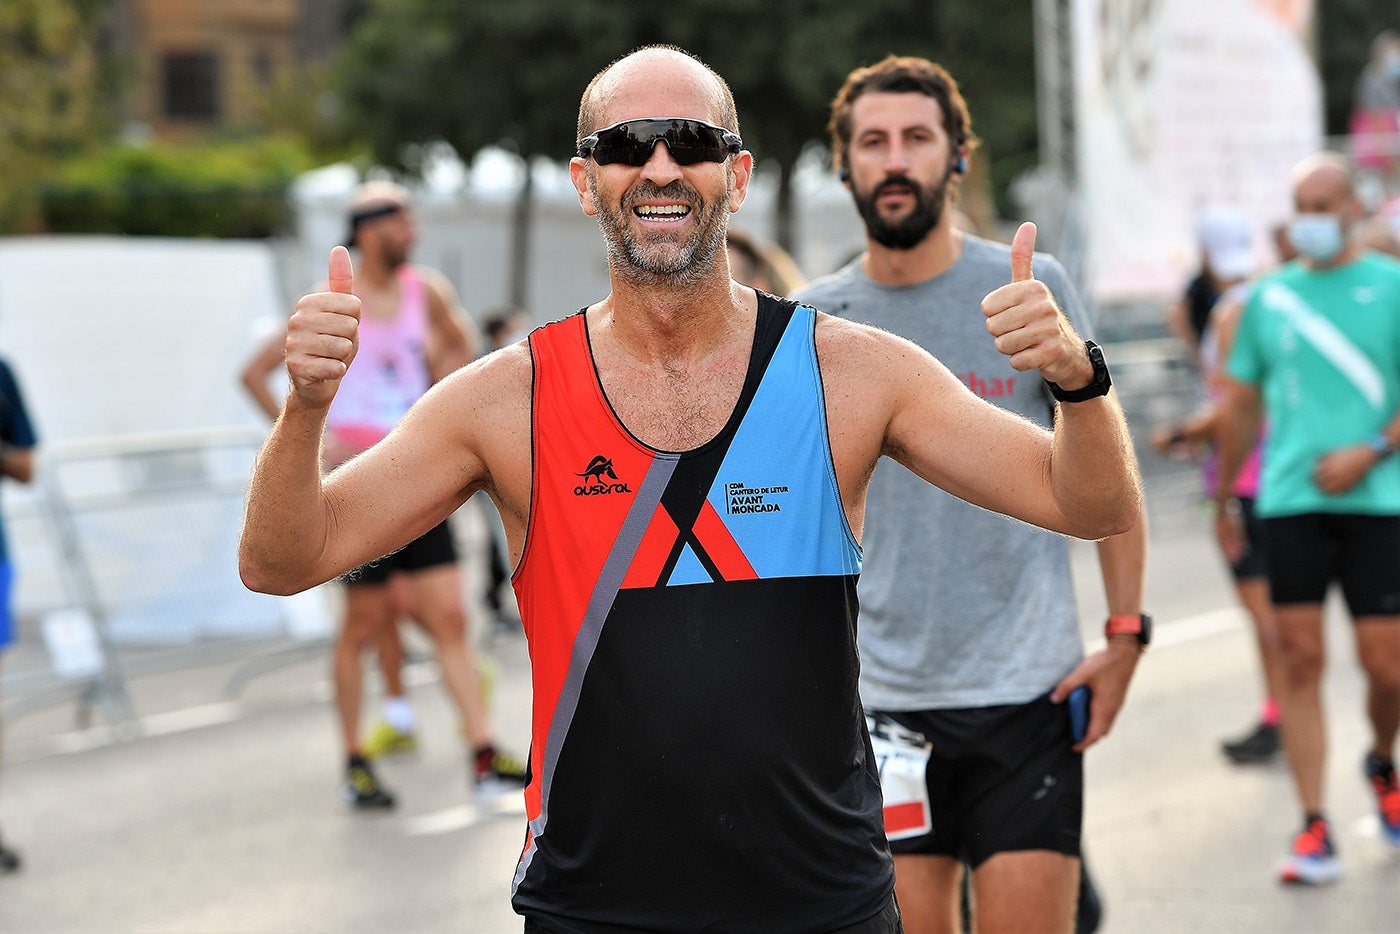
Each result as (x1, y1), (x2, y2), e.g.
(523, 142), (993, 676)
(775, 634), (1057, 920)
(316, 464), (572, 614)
(881, 696), (1084, 870)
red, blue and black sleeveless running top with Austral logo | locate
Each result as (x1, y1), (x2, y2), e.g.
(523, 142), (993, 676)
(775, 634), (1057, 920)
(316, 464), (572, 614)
(514, 294), (893, 934)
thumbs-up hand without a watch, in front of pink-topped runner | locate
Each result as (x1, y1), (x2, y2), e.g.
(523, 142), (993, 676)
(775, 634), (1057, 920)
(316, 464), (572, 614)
(286, 246), (360, 407)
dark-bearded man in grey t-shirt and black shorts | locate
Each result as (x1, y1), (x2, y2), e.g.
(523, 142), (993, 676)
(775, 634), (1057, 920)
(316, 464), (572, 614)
(794, 56), (1149, 931)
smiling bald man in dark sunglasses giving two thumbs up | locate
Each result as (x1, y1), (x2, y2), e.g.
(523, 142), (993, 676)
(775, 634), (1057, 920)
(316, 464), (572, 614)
(239, 46), (1141, 934)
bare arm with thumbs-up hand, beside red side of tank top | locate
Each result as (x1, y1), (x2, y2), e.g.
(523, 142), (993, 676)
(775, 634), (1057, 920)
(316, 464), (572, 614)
(239, 248), (529, 594)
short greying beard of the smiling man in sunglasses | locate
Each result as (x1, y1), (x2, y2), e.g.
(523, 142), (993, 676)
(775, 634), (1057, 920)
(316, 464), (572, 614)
(588, 178), (725, 287)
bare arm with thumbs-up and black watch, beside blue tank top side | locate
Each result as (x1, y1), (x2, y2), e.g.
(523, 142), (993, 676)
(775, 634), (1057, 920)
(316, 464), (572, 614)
(818, 224), (1142, 539)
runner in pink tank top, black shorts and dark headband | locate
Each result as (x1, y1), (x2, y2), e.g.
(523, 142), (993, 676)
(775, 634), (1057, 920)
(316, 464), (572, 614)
(244, 182), (526, 808)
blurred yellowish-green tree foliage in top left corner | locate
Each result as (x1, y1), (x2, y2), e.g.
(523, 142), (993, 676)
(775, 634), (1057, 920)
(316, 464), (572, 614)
(0, 0), (108, 232)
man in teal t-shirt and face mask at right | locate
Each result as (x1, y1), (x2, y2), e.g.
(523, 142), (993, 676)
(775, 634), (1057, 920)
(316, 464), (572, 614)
(1215, 153), (1400, 885)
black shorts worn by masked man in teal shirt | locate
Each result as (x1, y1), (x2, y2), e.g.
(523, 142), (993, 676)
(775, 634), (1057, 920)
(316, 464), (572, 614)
(1264, 513), (1400, 619)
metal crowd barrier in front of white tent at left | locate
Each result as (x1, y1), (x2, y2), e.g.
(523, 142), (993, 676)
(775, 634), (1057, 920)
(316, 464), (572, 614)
(0, 428), (330, 737)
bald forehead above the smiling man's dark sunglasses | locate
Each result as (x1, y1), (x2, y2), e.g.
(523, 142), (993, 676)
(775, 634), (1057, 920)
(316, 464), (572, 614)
(594, 56), (721, 129)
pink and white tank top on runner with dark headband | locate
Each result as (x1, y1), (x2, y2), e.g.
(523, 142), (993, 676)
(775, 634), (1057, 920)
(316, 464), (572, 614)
(326, 263), (433, 451)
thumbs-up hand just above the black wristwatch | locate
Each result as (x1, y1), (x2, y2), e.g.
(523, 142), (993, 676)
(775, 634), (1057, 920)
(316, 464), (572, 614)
(981, 223), (1093, 391)
